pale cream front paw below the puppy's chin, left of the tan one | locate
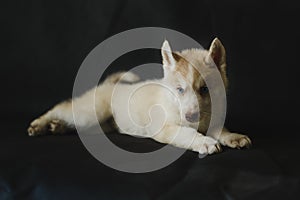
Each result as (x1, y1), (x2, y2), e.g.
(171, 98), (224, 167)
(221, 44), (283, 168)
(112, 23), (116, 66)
(198, 136), (222, 155)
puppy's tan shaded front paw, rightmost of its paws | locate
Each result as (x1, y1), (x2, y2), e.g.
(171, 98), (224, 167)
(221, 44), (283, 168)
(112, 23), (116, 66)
(222, 133), (252, 149)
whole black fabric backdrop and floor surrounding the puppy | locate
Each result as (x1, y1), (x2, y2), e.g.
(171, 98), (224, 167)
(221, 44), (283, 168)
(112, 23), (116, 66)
(0, 0), (300, 200)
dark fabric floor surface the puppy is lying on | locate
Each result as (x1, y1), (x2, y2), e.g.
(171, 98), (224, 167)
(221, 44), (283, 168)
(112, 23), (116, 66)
(0, 127), (300, 199)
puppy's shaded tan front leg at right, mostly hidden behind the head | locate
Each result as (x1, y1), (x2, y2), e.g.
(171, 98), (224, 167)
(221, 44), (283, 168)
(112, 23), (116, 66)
(206, 128), (252, 149)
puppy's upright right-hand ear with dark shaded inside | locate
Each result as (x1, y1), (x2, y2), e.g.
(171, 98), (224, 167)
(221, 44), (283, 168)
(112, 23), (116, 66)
(206, 38), (226, 72)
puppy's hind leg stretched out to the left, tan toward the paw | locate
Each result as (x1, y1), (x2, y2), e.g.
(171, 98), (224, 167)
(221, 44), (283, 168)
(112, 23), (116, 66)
(27, 84), (113, 136)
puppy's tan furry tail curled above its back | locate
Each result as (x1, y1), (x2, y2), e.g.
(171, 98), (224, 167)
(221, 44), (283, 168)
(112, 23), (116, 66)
(104, 72), (140, 84)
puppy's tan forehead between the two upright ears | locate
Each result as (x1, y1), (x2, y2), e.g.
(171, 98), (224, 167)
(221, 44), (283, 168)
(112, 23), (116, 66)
(176, 49), (208, 89)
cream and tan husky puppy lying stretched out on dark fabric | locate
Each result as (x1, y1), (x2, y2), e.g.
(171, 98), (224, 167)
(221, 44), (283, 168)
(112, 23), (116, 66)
(28, 38), (251, 154)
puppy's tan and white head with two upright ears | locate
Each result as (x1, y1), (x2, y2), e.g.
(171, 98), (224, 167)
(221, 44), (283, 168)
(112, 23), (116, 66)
(161, 38), (228, 126)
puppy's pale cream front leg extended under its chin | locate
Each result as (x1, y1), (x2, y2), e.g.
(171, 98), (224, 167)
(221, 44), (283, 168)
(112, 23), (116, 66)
(152, 125), (221, 154)
